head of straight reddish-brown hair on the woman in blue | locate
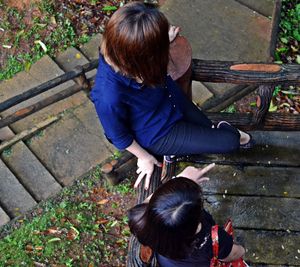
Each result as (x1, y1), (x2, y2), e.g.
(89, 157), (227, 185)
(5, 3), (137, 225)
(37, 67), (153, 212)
(101, 2), (169, 85)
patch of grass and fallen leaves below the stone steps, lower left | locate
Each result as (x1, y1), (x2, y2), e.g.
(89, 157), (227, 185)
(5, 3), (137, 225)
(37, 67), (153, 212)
(0, 168), (134, 267)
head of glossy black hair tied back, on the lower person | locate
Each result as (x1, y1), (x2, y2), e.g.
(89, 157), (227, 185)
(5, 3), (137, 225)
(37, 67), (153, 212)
(128, 178), (203, 259)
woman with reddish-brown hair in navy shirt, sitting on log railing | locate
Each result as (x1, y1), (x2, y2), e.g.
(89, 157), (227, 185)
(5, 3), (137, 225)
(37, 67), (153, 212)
(91, 2), (251, 189)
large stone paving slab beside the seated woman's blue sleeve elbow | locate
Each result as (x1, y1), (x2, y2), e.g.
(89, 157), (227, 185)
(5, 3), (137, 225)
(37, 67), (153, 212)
(28, 101), (114, 185)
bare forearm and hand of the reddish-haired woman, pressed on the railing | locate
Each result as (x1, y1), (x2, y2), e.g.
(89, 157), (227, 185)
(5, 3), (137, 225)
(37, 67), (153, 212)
(126, 140), (162, 190)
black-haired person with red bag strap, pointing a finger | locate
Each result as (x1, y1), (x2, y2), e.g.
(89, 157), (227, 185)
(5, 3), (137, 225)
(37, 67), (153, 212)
(128, 164), (245, 267)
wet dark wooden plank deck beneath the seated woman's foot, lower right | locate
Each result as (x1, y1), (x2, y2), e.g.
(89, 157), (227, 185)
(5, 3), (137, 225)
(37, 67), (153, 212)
(190, 132), (300, 266)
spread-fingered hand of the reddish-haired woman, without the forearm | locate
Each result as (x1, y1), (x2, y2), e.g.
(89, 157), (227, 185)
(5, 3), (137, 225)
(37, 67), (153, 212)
(134, 154), (162, 190)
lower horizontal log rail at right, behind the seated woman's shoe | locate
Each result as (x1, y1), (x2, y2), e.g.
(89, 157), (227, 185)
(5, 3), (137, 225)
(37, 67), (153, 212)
(206, 112), (300, 131)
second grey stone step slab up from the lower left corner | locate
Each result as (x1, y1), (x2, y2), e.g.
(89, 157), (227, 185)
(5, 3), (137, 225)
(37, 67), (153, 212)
(0, 160), (37, 217)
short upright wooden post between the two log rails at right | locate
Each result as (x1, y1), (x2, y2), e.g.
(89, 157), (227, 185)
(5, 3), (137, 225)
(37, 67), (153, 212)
(253, 85), (275, 127)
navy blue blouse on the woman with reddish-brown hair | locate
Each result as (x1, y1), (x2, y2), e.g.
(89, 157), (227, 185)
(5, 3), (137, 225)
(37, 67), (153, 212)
(91, 55), (185, 149)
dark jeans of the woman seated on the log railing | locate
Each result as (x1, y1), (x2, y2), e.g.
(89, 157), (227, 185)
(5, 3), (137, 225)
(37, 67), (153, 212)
(148, 99), (240, 155)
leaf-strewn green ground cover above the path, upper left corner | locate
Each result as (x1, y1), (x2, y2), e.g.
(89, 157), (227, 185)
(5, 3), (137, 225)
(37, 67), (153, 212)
(0, 0), (127, 81)
